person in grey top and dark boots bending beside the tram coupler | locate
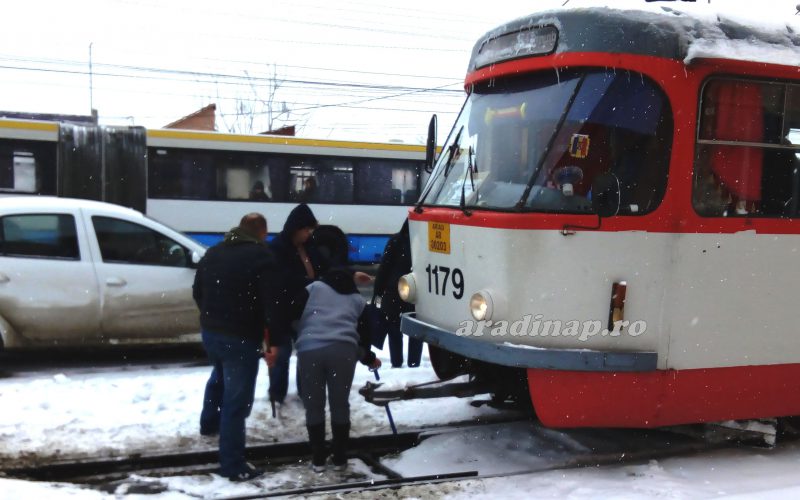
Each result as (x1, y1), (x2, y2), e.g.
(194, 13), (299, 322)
(295, 268), (381, 472)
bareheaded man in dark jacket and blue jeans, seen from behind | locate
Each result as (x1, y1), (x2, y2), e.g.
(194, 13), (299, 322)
(193, 213), (284, 481)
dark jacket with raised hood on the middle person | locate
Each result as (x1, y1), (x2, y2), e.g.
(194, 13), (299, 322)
(270, 203), (328, 338)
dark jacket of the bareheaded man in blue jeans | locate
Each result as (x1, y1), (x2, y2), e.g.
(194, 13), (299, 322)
(192, 227), (283, 345)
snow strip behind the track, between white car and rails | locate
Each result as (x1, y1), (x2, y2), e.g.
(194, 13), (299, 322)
(0, 346), (506, 465)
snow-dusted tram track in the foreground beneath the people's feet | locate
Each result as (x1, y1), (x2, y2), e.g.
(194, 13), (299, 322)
(2, 420), (788, 500)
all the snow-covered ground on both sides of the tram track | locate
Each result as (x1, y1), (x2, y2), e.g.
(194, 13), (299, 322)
(0, 342), (800, 500)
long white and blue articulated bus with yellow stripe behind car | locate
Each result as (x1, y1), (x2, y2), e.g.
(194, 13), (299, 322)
(0, 119), (427, 263)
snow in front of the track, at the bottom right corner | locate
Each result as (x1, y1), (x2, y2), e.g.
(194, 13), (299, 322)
(348, 443), (800, 500)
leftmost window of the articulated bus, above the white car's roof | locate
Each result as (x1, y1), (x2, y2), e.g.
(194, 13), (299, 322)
(0, 139), (56, 194)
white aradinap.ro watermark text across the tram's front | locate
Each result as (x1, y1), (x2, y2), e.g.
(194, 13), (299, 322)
(455, 314), (647, 342)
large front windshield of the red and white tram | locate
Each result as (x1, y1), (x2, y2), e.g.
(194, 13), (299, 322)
(423, 70), (672, 214)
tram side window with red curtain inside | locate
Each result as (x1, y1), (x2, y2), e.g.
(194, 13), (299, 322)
(692, 78), (800, 218)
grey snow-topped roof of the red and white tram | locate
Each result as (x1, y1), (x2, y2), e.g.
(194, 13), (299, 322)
(469, 0), (800, 71)
